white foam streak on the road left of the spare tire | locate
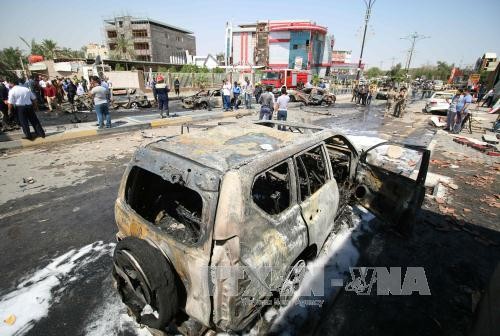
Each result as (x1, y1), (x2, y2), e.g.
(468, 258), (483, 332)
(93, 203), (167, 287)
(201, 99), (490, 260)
(0, 241), (115, 336)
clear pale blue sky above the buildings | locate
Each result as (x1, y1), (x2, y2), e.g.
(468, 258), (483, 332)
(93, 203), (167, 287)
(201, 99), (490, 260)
(0, 0), (500, 69)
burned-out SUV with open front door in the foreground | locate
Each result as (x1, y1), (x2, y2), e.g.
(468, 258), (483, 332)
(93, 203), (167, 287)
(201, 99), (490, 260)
(113, 121), (429, 334)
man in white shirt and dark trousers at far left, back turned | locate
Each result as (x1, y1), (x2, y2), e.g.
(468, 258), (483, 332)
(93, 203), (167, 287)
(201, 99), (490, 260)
(7, 80), (45, 140)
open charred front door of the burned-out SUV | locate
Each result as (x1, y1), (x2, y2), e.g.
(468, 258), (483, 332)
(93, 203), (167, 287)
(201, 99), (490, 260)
(355, 142), (430, 233)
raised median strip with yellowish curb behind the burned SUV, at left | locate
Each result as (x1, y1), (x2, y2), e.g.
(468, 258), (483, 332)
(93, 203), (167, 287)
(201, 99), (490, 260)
(0, 108), (257, 150)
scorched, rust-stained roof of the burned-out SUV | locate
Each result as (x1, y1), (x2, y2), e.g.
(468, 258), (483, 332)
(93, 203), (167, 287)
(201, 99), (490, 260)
(147, 123), (335, 172)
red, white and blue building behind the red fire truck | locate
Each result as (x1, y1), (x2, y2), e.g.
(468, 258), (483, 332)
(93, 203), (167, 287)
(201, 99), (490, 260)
(226, 20), (332, 76)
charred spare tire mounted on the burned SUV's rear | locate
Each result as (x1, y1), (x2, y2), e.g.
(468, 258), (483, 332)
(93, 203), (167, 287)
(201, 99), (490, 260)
(113, 237), (178, 329)
